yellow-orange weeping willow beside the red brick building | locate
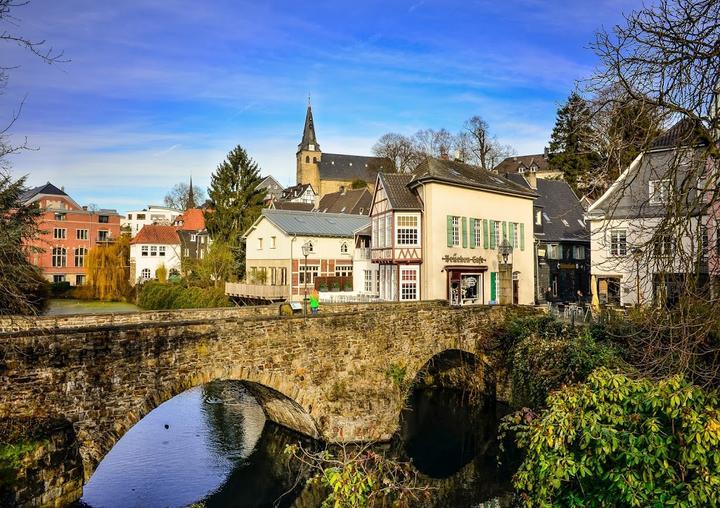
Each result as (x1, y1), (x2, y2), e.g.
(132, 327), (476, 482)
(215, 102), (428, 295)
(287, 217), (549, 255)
(85, 235), (130, 301)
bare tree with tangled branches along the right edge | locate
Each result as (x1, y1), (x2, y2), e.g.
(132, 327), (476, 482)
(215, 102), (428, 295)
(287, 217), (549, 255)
(585, 0), (720, 384)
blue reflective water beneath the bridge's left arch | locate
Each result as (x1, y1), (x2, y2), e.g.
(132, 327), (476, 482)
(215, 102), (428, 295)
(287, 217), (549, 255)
(81, 381), (306, 508)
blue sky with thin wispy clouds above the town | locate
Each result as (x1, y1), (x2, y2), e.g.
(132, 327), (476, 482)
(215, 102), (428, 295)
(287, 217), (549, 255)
(0, 0), (640, 211)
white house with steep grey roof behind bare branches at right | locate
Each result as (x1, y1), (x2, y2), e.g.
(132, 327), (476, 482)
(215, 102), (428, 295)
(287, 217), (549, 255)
(586, 122), (711, 305)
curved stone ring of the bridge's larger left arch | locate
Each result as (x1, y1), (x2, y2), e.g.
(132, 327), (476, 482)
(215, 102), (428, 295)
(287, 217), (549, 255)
(77, 365), (320, 482)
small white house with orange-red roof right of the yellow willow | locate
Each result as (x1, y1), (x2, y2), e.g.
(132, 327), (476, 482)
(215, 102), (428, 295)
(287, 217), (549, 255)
(130, 225), (181, 283)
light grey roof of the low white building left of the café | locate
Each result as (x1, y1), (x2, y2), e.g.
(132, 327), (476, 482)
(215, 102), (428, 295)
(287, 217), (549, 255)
(250, 208), (370, 238)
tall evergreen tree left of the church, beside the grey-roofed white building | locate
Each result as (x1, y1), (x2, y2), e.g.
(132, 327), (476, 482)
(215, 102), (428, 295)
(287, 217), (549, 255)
(205, 145), (265, 278)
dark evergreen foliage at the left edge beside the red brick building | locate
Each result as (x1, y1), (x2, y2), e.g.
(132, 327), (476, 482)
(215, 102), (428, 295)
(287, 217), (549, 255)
(0, 172), (49, 315)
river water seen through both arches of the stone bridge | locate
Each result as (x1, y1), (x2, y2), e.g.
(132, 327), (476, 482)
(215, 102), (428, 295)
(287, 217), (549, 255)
(78, 381), (511, 508)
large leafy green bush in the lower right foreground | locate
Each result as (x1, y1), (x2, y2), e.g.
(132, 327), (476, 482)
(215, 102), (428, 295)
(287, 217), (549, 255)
(511, 369), (720, 507)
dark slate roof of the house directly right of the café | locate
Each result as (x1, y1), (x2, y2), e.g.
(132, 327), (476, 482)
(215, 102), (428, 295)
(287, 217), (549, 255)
(506, 173), (590, 242)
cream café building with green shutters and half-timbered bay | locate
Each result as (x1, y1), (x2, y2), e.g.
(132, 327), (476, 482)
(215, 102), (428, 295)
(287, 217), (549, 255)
(370, 158), (536, 305)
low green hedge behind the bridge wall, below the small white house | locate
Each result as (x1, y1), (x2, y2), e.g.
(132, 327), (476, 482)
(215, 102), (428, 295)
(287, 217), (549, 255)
(138, 281), (230, 310)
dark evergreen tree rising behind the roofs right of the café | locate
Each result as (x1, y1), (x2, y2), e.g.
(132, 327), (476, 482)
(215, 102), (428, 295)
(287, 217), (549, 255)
(549, 92), (598, 194)
